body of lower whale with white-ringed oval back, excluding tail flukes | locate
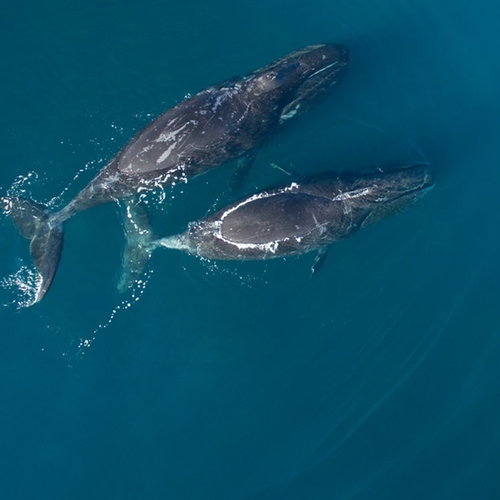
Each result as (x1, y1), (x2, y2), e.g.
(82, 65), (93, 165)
(129, 163), (434, 270)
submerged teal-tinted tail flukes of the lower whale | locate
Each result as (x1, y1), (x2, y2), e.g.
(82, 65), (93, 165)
(117, 201), (154, 293)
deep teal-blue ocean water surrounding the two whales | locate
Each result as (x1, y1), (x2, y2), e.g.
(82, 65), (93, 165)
(0, 0), (500, 500)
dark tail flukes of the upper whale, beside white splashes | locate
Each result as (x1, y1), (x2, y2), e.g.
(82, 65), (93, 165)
(1, 198), (63, 303)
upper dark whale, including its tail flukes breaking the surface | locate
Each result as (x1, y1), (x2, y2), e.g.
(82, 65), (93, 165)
(0, 44), (349, 301)
